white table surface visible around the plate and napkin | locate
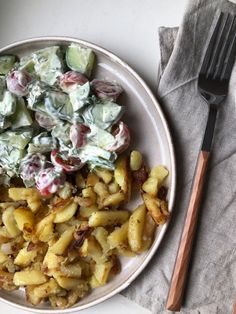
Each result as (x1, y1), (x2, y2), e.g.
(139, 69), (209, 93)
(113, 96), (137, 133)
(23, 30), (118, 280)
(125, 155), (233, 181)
(0, 0), (187, 314)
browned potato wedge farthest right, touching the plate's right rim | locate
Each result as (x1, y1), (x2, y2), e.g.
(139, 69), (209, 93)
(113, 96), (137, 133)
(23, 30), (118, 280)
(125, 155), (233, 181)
(143, 193), (169, 225)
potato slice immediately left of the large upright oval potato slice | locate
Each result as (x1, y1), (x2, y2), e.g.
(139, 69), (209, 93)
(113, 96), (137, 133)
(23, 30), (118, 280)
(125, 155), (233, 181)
(107, 221), (129, 249)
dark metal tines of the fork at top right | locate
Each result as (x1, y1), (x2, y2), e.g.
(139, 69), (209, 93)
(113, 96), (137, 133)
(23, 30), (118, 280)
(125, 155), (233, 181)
(200, 12), (236, 80)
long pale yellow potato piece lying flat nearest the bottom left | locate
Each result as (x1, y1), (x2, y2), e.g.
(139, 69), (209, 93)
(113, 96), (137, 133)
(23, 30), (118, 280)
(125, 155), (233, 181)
(13, 269), (48, 286)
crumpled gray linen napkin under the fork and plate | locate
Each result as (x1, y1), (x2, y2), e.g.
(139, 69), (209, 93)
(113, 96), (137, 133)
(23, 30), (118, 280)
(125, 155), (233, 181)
(124, 0), (236, 314)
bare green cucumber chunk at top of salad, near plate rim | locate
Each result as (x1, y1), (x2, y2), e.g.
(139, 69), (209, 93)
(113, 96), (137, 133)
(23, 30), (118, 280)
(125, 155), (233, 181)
(66, 43), (95, 77)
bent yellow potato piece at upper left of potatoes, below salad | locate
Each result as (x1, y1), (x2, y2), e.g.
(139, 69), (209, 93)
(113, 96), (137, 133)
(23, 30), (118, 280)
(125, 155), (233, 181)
(8, 188), (42, 213)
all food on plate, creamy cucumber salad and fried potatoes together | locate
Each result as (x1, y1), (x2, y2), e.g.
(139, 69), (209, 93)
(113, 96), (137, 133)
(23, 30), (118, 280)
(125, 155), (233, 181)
(0, 43), (169, 308)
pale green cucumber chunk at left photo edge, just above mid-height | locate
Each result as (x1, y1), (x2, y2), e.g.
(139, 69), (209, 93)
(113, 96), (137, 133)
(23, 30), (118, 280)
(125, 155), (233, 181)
(0, 128), (33, 149)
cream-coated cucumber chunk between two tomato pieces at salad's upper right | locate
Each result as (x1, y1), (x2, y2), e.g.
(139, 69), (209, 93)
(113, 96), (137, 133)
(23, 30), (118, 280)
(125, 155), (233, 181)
(69, 82), (90, 111)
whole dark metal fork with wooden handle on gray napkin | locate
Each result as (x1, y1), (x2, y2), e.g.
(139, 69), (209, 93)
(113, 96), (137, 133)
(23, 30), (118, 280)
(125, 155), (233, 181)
(166, 12), (236, 311)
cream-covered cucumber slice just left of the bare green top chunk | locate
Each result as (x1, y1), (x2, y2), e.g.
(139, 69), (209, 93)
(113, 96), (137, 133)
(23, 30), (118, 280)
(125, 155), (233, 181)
(32, 46), (63, 85)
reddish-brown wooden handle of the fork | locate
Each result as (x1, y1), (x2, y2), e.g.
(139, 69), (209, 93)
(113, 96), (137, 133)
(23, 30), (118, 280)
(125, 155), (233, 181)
(166, 151), (209, 311)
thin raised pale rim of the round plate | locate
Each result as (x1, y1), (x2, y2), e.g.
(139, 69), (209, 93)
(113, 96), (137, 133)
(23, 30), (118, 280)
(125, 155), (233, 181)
(0, 36), (177, 314)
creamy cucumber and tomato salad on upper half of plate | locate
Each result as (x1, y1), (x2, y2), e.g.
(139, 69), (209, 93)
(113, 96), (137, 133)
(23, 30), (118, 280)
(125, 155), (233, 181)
(0, 43), (130, 196)
